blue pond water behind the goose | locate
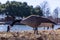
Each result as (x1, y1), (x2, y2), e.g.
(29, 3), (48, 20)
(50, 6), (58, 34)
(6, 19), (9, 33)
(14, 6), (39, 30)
(0, 25), (60, 31)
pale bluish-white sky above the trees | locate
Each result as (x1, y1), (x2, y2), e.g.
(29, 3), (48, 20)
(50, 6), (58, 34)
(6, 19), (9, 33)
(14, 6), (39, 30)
(0, 0), (60, 15)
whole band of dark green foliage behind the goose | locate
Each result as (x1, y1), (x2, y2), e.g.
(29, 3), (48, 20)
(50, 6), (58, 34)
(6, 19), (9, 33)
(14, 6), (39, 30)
(0, 1), (43, 17)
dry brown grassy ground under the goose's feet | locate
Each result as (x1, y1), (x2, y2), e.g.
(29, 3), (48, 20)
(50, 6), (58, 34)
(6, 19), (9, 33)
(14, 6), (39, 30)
(0, 29), (60, 40)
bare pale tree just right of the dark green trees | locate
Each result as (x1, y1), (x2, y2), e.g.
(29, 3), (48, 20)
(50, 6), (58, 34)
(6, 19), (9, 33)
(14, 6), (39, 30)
(41, 1), (50, 17)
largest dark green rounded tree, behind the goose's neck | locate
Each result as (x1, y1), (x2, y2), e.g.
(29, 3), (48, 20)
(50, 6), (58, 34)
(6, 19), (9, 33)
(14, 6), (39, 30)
(6, 1), (30, 17)
